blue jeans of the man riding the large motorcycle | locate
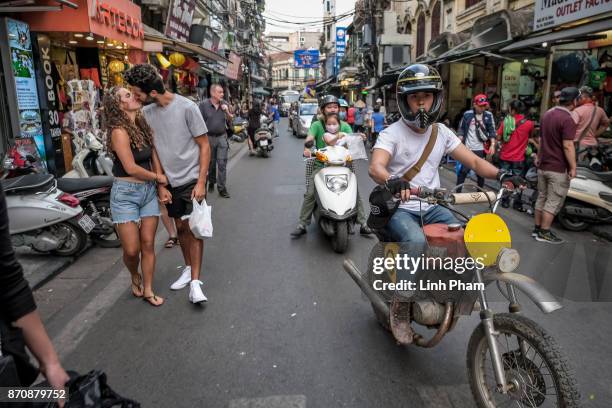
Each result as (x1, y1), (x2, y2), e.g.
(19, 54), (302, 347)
(385, 205), (458, 248)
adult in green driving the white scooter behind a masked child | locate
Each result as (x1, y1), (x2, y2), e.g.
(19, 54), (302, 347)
(291, 95), (372, 238)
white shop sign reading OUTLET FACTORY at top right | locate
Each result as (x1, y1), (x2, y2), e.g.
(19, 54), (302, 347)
(533, 0), (612, 31)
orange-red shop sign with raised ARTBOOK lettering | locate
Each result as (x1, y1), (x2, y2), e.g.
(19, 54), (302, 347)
(88, 0), (144, 48)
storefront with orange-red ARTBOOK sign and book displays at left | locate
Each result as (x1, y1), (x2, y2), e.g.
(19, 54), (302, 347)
(2, 0), (144, 175)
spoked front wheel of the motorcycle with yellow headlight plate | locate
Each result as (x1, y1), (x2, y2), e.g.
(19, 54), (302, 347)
(467, 314), (580, 408)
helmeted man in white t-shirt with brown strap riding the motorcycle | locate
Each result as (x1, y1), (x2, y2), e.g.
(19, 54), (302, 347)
(368, 64), (505, 343)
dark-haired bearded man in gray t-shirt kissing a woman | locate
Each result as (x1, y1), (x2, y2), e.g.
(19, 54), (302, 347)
(124, 64), (210, 303)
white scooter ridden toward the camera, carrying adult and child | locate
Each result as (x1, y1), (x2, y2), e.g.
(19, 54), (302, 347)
(314, 146), (357, 253)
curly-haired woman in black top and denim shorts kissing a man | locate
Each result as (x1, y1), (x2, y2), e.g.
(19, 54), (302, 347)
(104, 87), (168, 306)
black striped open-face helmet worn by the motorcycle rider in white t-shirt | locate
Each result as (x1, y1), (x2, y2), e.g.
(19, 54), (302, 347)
(397, 64), (444, 129)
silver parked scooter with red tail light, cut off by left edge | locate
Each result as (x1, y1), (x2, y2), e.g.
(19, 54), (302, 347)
(2, 174), (95, 256)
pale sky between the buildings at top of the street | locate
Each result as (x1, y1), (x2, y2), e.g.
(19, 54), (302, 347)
(264, 0), (355, 33)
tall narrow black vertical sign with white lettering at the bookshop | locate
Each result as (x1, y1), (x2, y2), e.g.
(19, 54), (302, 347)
(38, 34), (62, 143)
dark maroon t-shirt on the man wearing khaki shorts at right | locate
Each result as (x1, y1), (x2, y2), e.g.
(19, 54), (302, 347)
(538, 107), (577, 173)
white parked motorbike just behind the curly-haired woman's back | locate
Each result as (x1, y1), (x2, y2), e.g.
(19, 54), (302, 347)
(64, 132), (113, 178)
